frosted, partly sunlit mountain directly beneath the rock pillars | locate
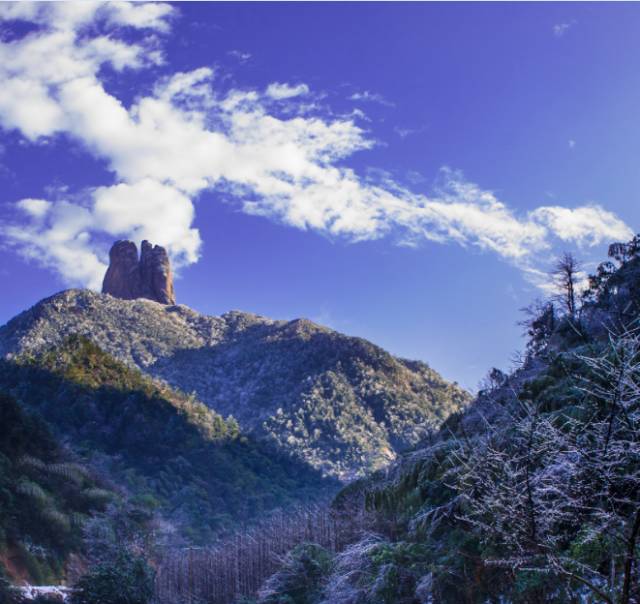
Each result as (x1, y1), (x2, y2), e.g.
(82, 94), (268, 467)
(0, 290), (470, 480)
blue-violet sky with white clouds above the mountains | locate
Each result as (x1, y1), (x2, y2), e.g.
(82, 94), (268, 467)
(0, 1), (640, 388)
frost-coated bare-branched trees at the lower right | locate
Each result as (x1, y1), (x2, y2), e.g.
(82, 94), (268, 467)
(447, 332), (640, 604)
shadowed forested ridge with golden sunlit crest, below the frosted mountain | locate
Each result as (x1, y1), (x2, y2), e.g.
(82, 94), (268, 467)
(0, 336), (335, 544)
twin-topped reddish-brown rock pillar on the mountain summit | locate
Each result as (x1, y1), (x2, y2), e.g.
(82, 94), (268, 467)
(102, 241), (176, 304)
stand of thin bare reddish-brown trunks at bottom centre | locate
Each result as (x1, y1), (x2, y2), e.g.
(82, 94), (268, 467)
(156, 497), (373, 604)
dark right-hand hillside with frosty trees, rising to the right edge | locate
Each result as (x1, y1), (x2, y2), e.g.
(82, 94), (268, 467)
(248, 238), (640, 604)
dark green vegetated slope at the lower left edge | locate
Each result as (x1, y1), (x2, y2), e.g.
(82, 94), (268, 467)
(0, 393), (115, 583)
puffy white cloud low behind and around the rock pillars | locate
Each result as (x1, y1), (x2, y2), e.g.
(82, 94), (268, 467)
(4, 180), (201, 288)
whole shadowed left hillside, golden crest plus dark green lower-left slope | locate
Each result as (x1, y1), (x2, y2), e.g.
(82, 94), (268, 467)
(0, 337), (336, 582)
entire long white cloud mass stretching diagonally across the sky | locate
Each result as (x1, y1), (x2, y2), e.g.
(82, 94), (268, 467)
(0, 3), (631, 287)
